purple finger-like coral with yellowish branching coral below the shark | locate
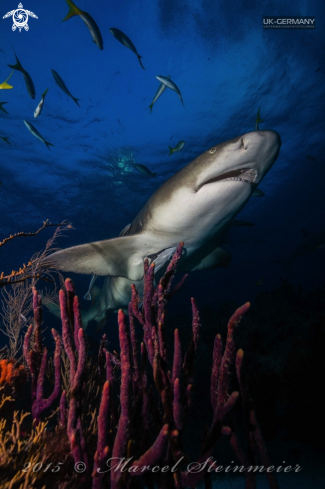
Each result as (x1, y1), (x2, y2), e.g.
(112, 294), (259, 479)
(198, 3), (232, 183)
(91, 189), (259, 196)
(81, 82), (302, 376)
(0, 243), (278, 489)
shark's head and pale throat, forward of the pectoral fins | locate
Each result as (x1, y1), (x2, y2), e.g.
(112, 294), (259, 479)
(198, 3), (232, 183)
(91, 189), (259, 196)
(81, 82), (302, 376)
(150, 131), (281, 241)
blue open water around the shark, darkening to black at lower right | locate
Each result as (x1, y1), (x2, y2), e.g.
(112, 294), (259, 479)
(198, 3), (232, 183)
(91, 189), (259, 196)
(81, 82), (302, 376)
(0, 0), (325, 489)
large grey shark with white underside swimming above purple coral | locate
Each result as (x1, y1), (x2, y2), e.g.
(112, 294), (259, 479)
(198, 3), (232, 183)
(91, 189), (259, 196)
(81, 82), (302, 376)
(43, 130), (281, 324)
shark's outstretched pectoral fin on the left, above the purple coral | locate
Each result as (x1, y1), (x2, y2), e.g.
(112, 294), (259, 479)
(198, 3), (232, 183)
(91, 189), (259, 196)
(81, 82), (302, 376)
(42, 234), (155, 281)
